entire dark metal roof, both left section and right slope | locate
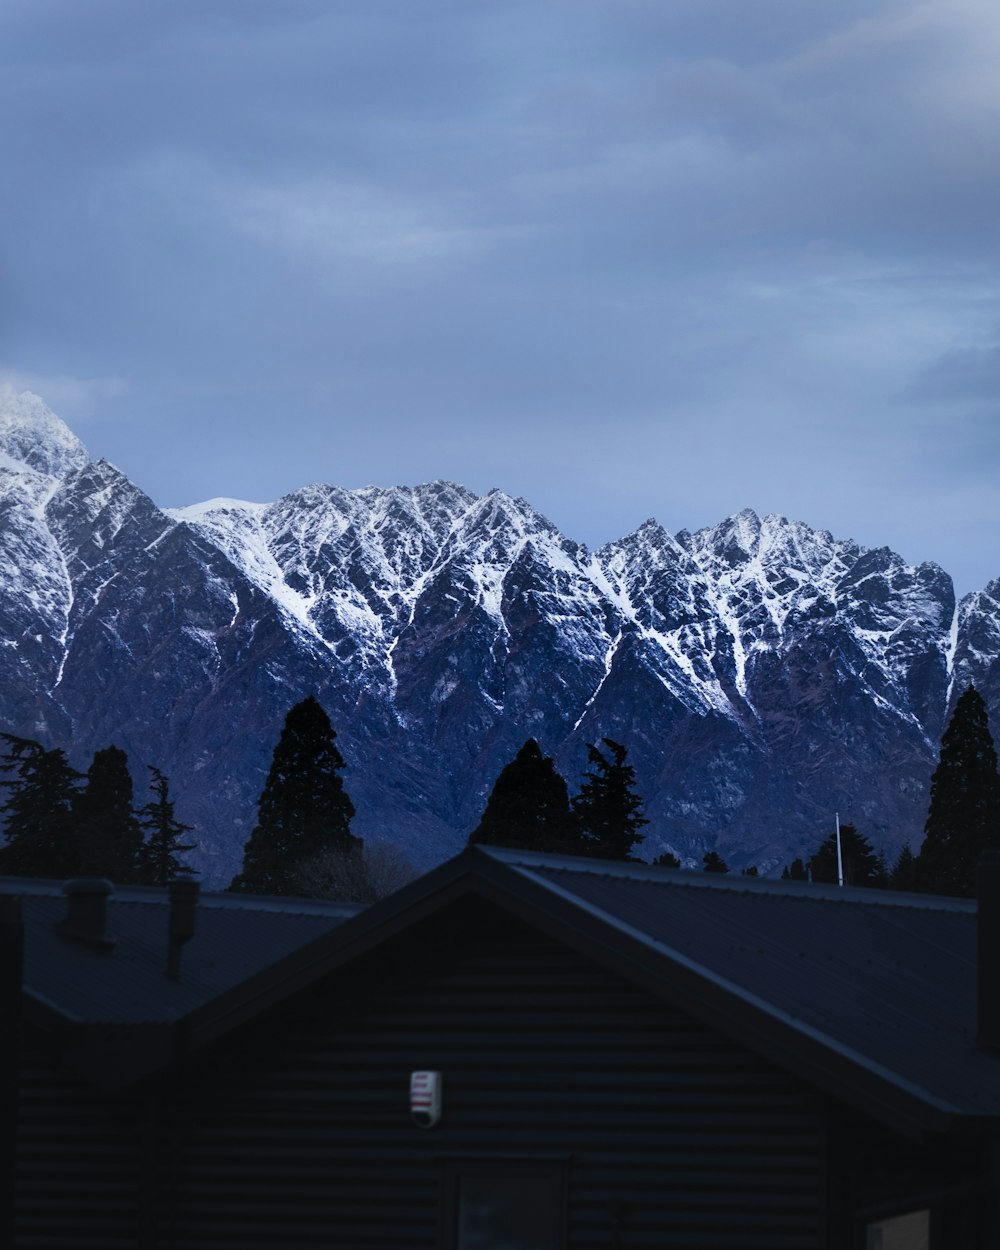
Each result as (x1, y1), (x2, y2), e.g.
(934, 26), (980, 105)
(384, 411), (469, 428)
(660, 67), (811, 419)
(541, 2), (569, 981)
(0, 846), (1000, 1133)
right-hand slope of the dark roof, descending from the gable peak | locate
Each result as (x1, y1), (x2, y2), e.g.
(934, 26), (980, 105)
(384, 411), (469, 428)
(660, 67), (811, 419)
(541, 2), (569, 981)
(472, 850), (1000, 1125)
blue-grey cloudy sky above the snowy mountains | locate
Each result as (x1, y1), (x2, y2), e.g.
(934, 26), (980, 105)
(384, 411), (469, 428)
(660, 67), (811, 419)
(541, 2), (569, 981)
(0, 0), (1000, 593)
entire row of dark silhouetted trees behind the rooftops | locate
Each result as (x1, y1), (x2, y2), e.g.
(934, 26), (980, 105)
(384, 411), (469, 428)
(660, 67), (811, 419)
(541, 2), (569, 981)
(0, 686), (1000, 903)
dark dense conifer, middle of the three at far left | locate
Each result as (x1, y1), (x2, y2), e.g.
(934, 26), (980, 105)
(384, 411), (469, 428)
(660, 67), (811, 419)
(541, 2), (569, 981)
(73, 746), (143, 883)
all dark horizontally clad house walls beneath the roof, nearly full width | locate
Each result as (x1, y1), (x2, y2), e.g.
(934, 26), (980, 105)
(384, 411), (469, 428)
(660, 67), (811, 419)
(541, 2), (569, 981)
(14, 900), (994, 1250)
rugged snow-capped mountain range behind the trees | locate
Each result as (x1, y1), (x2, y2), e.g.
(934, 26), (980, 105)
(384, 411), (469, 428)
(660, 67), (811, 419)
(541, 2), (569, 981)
(0, 395), (1000, 881)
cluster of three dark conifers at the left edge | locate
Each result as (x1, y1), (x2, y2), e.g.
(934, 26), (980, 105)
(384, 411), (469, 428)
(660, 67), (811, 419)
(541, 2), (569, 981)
(0, 734), (195, 885)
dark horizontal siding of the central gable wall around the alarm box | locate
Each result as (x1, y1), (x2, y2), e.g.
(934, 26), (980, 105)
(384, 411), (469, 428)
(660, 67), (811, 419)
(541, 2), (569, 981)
(158, 918), (823, 1250)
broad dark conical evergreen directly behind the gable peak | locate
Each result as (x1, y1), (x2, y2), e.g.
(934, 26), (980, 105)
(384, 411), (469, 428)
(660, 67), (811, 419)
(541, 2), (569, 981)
(469, 738), (583, 855)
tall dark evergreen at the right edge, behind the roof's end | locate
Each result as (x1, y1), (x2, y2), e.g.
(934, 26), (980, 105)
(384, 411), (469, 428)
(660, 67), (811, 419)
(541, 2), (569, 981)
(916, 686), (1000, 898)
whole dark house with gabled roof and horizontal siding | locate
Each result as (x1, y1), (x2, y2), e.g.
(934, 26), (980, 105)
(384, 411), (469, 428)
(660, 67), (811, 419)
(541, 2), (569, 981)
(0, 848), (1000, 1250)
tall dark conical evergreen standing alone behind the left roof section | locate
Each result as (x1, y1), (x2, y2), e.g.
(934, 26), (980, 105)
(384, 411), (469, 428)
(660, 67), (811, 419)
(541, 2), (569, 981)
(230, 695), (361, 894)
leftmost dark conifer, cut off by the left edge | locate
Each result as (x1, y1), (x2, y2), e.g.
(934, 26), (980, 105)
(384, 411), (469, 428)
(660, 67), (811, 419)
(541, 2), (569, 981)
(0, 734), (81, 879)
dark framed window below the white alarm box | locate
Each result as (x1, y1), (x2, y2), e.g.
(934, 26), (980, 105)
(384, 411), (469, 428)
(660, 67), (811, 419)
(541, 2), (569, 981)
(444, 1160), (565, 1250)
